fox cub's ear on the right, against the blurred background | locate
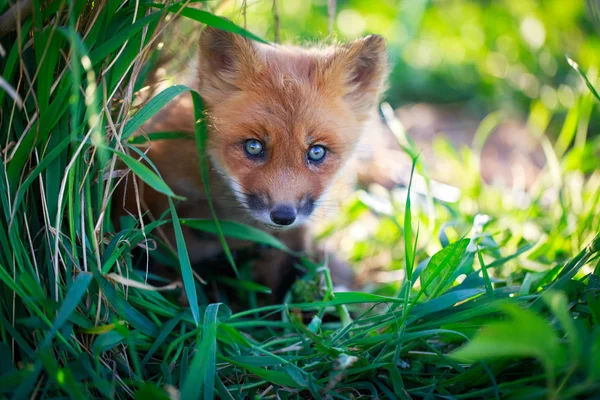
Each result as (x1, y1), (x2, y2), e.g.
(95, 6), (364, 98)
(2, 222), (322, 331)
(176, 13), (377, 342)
(328, 35), (388, 118)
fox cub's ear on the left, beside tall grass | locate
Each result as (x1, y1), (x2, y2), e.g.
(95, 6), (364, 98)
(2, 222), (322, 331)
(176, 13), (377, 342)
(198, 26), (260, 104)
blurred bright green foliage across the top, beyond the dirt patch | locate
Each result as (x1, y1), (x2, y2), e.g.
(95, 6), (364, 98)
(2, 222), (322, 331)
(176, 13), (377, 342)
(217, 0), (600, 132)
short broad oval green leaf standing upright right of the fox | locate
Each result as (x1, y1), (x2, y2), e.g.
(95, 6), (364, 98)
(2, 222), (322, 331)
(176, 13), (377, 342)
(420, 239), (469, 297)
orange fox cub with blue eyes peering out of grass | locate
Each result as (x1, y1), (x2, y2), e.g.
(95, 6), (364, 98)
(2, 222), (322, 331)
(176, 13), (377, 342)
(121, 28), (387, 302)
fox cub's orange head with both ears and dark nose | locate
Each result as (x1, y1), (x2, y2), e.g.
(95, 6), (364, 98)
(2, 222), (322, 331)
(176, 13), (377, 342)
(198, 28), (387, 230)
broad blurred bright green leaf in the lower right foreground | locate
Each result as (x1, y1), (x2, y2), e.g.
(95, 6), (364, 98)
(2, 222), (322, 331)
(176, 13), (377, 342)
(452, 304), (566, 375)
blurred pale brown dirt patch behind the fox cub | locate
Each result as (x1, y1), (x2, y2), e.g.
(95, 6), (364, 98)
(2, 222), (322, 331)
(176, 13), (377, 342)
(359, 104), (545, 191)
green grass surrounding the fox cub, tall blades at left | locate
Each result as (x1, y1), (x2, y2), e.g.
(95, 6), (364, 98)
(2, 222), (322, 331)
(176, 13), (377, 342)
(0, 0), (600, 399)
